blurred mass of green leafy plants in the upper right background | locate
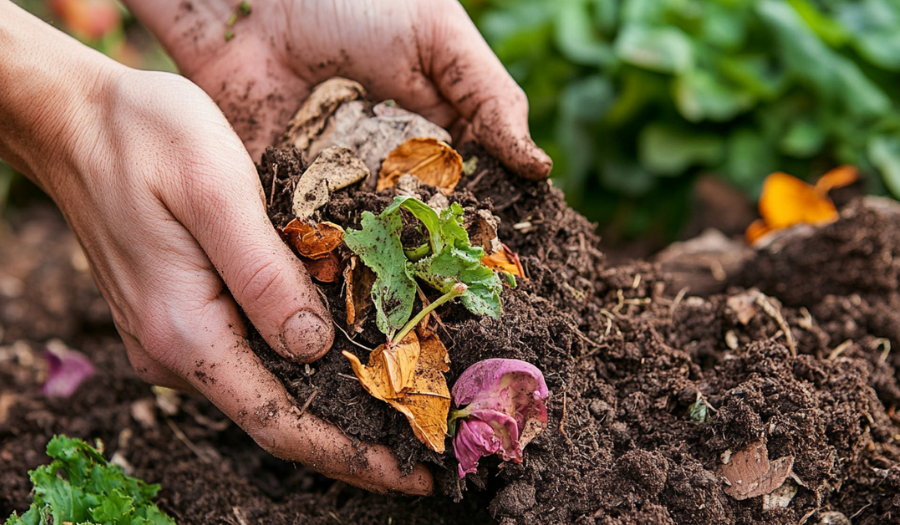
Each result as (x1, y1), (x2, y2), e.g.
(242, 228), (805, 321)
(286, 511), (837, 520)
(463, 0), (900, 234)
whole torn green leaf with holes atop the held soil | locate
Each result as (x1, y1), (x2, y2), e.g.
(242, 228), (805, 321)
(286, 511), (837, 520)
(344, 197), (502, 335)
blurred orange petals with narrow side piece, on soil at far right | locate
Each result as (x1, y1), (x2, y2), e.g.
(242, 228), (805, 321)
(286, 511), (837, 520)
(746, 166), (859, 244)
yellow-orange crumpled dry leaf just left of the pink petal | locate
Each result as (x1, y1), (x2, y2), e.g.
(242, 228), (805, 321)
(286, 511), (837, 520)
(344, 335), (450, 454)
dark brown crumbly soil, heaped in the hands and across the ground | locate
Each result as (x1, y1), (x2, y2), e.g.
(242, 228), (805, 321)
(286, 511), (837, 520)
(0, 146), (900, 525)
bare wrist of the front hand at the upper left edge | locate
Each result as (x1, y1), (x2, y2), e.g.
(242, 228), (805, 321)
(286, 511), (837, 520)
(0, 0), (125, 192)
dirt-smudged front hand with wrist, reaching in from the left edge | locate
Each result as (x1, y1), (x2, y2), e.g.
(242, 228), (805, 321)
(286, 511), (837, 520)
(0, 0), (431, 494)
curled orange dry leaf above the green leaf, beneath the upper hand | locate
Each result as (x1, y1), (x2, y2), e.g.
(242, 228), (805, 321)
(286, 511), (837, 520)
(377, 137), (462, 195)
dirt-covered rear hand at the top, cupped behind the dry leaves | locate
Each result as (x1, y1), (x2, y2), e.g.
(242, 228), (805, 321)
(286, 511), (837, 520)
(126, 0), (552, 179)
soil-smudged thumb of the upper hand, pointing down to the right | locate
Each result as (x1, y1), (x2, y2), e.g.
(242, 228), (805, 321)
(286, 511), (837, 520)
(421, 2), (553, 180)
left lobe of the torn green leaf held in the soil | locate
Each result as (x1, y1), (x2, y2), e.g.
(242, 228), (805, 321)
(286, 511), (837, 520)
(344, 205), (416, 335)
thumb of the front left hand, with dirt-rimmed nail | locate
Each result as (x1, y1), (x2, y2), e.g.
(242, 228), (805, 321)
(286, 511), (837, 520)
(170, 136), (334, 362)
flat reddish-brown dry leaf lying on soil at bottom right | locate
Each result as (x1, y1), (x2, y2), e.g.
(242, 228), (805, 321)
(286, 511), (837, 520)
(719, 440), (794, 500)
